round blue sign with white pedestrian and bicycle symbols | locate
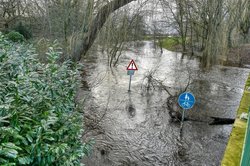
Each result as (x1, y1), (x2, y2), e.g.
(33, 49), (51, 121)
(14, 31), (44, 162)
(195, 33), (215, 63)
(178, 92), (195, 109)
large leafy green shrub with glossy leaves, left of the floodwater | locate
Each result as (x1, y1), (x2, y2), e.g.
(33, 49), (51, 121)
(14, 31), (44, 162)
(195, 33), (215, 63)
(0, 34), (90, 165)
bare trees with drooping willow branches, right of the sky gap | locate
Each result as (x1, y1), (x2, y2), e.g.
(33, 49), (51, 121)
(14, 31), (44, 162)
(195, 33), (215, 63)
(161, 0), (250, 67)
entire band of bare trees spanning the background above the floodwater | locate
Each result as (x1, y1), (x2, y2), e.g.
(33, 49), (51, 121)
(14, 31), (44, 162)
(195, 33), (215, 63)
(0, 0), (250, 67)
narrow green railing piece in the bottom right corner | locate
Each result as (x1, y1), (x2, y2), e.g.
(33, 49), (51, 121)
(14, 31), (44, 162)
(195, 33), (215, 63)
(240, 107), (250, 166)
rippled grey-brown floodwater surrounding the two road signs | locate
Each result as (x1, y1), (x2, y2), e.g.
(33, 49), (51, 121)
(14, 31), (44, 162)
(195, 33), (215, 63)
(78, 41), (249, 166)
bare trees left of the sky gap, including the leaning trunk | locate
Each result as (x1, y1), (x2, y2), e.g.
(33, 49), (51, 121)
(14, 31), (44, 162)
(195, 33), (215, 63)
(0, 0), (144, 65)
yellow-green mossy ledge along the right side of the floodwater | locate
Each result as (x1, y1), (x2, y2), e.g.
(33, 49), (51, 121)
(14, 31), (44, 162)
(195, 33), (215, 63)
(221, 74), (250, 166)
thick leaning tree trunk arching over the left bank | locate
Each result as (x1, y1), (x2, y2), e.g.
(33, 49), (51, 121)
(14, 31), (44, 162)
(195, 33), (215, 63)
(72, 0), (135, 62)
